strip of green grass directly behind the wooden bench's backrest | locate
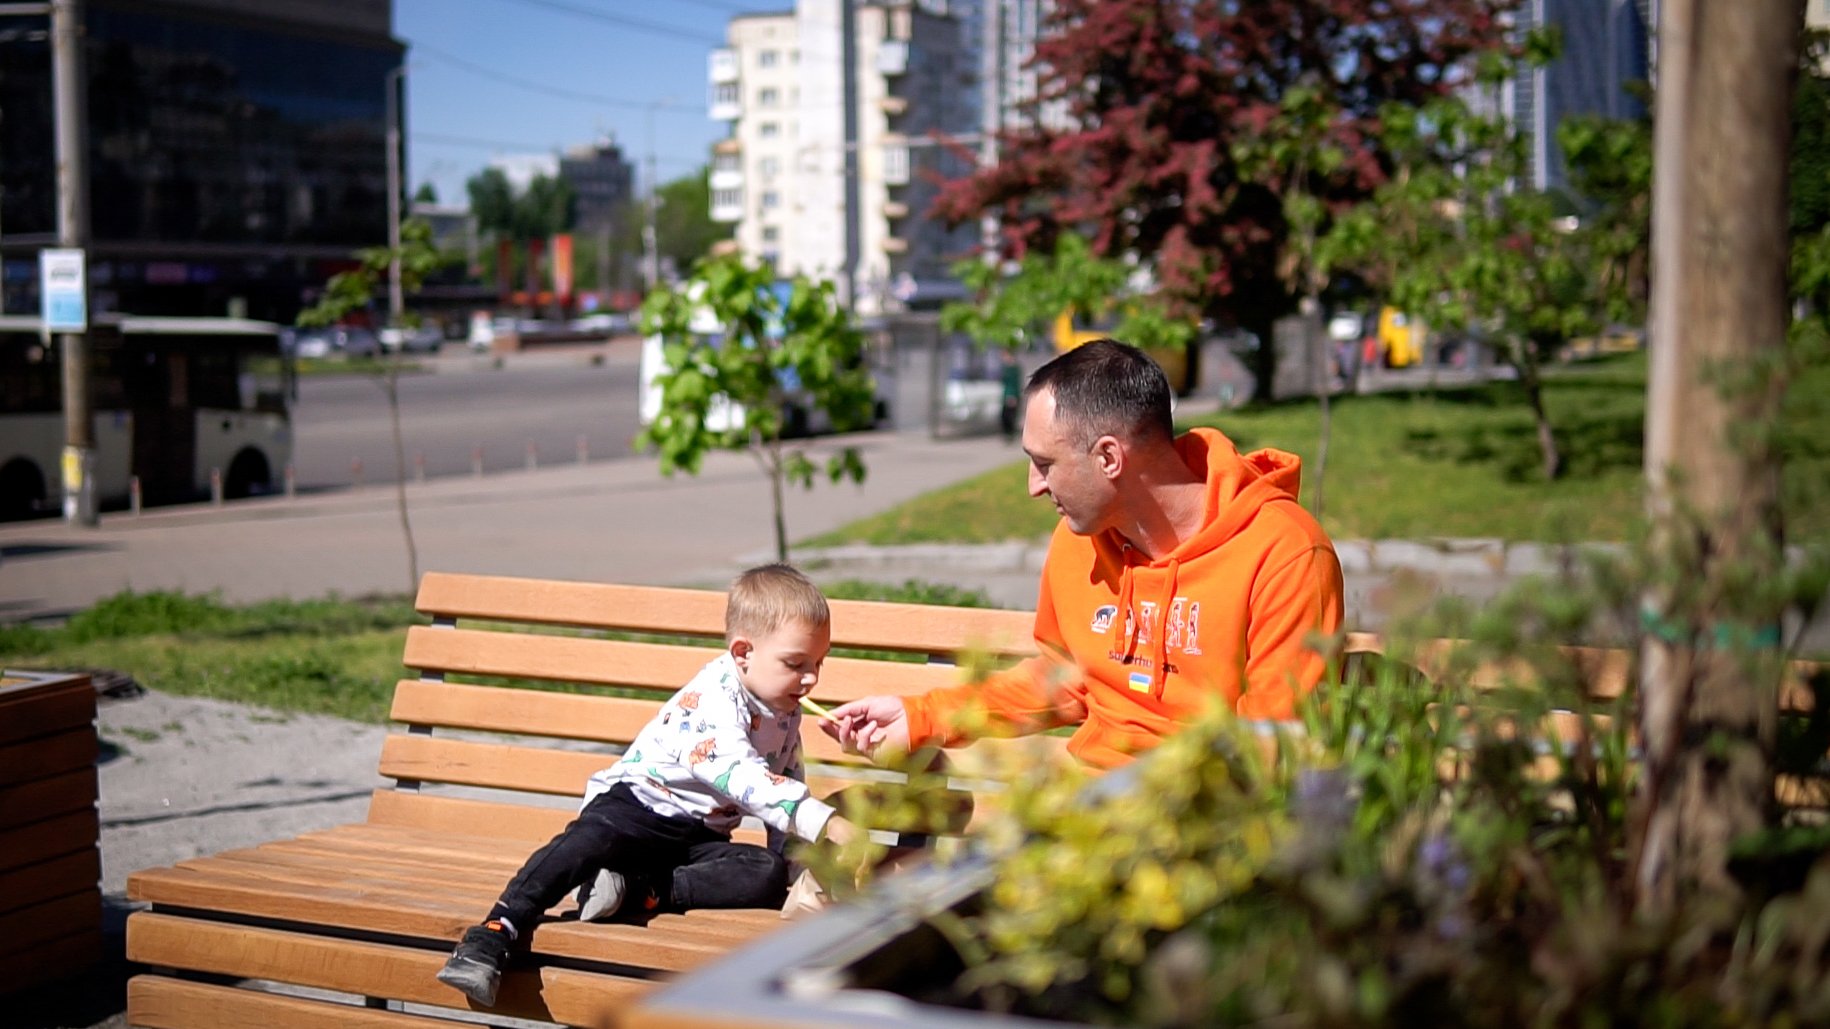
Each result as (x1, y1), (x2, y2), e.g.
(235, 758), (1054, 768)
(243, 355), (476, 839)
(0, 580), (990, 723)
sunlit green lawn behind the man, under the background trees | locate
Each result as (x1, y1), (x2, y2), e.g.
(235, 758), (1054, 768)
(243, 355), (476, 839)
(805, 355), (1830, 546)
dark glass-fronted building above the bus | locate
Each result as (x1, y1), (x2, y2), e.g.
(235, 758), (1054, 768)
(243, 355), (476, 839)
(0, 0), (404, 320)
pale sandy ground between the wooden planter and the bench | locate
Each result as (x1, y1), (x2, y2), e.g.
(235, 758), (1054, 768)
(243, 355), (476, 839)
(15, 692), (386, 1029)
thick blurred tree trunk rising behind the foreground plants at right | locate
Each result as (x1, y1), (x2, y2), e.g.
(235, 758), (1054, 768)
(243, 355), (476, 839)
(1634, 0), (1801, 915)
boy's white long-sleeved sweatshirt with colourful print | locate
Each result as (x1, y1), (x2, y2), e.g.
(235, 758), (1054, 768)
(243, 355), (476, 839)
(584, 652), (833, 850)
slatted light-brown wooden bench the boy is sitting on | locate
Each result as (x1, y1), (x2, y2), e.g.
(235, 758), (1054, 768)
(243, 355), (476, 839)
(126, 573), (1034, 1029)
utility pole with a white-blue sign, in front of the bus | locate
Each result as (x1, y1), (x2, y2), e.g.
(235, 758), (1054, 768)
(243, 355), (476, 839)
(51, 0), (97, 525)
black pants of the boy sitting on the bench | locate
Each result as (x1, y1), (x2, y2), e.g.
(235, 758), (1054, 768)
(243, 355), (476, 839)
(489, 782), (789, 934)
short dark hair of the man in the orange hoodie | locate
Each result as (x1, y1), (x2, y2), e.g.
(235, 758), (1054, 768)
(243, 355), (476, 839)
(1023, 339), (1175, 447)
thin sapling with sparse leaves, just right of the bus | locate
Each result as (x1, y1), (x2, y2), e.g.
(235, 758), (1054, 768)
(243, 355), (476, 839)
(298, 218), (450, 591)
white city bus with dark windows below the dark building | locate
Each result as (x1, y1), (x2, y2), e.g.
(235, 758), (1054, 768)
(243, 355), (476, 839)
(0, 315), (296, 518)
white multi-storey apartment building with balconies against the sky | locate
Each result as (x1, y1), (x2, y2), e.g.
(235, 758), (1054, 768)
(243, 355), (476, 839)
(708, 0), (981, 315)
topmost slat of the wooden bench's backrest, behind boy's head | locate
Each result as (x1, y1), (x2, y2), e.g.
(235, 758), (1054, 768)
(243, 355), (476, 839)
(417, 571), (1036, 655)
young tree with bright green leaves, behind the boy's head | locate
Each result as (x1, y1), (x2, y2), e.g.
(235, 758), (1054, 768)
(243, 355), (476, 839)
(635, 258), (875, 560)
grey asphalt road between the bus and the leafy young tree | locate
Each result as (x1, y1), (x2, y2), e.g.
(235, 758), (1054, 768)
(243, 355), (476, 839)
(293, 347), (639, 491)
